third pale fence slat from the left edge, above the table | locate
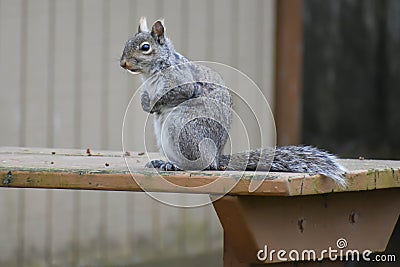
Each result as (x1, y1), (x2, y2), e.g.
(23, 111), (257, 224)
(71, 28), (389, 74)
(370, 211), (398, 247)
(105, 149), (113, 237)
(49, 0), (76, 148)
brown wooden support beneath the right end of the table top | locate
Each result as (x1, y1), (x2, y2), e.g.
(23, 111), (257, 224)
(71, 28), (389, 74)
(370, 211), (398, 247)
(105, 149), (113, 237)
(213, 188), (400, 267)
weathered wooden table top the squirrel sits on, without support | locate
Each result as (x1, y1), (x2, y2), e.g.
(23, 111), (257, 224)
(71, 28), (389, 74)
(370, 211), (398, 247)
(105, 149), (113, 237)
(0, 147), (400, 196)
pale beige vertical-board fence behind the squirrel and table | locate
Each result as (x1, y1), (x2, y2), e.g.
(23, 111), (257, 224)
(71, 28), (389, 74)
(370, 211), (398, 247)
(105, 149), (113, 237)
(0, 0), (275, 266)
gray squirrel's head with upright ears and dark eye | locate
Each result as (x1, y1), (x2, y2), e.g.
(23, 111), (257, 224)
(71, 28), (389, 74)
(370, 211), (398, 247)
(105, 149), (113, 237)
(120, 17), (170, 74)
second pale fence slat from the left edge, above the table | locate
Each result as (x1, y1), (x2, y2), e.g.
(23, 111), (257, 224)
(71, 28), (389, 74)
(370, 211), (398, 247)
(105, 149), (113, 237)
(25, 0), (49, 147)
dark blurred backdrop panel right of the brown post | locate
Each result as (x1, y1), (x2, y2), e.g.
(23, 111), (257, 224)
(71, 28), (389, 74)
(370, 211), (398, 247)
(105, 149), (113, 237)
(303, 0), (400, 159)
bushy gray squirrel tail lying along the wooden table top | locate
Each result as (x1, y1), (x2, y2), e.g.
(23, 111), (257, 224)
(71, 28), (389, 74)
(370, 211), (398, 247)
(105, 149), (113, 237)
(220, 146), (347, 187)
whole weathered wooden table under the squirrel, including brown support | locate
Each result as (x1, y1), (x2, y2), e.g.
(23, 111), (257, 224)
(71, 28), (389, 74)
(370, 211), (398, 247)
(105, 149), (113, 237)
(0, 147), (400, 266)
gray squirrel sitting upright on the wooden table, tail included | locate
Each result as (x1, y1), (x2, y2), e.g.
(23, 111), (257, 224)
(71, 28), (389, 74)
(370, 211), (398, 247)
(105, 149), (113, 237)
(120, 17), (346, 186)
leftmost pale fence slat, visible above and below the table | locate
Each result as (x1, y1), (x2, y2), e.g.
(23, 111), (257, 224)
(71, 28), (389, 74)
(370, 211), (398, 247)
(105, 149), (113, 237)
(0, 0), (24, 266)
